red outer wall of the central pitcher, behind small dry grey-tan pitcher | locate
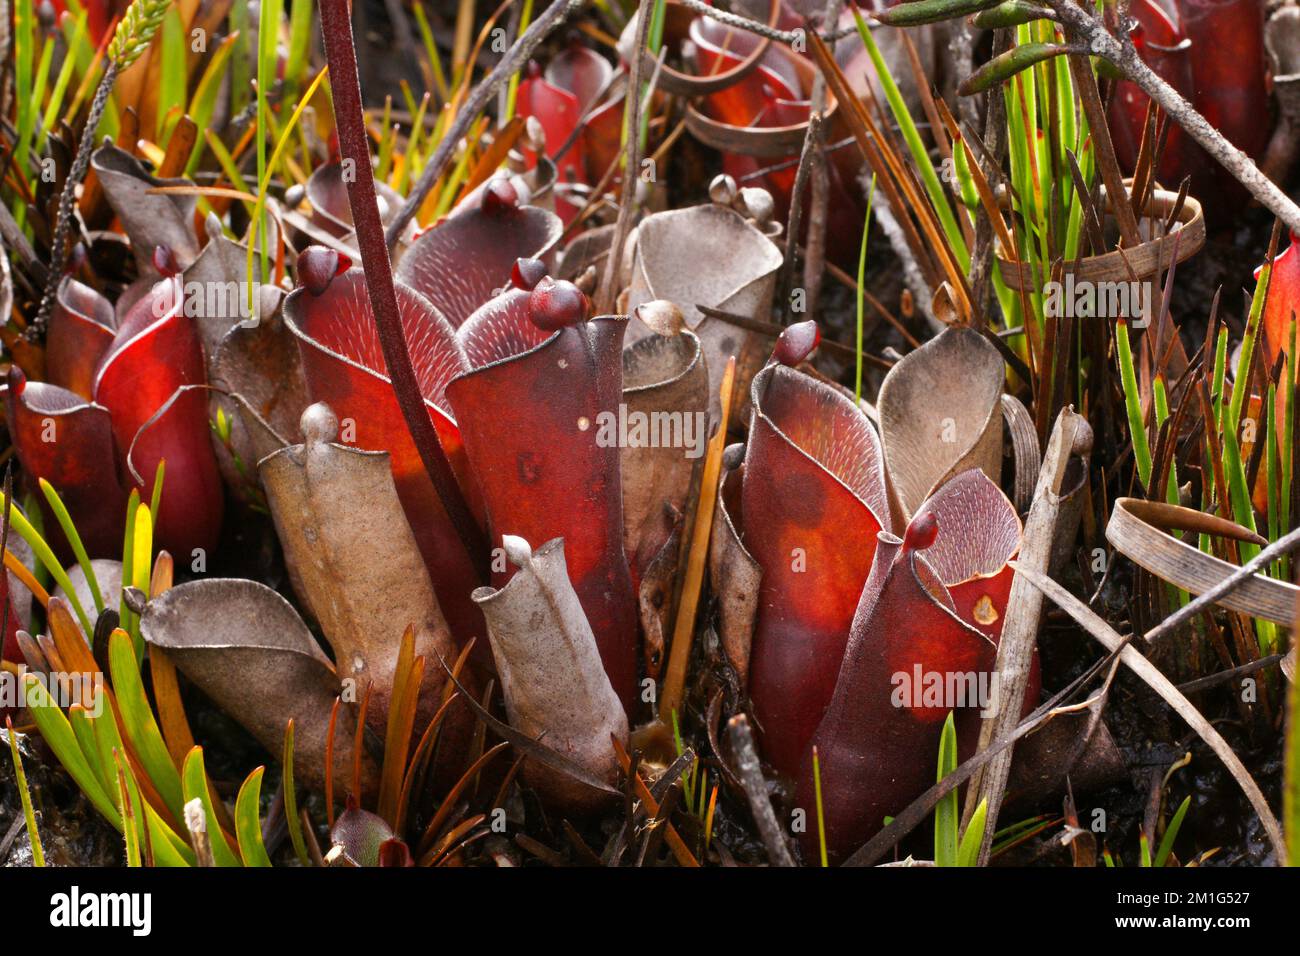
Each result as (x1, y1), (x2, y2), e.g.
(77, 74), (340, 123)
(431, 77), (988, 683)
(447, 316), (637, 709)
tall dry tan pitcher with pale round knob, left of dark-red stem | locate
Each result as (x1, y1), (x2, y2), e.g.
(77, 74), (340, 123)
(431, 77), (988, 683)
(257, 403), (473, 735)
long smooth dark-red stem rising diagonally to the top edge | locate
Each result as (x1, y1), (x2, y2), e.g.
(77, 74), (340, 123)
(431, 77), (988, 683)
(321, 0), (488, 580)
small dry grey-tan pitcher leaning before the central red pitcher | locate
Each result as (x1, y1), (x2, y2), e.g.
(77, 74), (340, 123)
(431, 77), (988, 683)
(475, 535), (628, 812)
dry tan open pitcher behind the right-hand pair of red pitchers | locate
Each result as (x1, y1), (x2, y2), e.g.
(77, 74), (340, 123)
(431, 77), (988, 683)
(876, 328), (1005, 527)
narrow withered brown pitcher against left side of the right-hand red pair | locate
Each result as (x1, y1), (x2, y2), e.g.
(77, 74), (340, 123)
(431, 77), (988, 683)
(709, 445), (763, 687)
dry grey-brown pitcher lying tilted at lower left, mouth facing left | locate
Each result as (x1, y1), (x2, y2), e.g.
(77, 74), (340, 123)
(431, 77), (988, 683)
(140, 578), (378, 797)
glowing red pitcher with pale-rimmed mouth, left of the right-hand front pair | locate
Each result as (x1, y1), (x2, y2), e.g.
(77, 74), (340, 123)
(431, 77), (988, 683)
(741, 364), (889, 777)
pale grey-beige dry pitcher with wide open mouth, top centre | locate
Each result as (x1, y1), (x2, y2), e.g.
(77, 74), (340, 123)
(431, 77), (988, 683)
(627, 196), (783, 421)
